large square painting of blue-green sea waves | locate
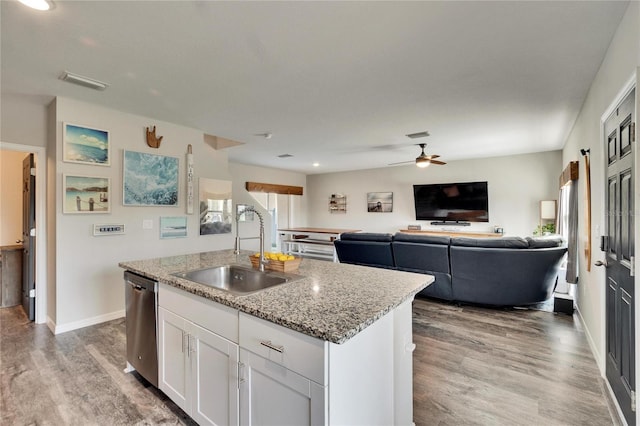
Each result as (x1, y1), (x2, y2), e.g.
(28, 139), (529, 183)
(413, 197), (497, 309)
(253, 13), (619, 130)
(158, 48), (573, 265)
(122, 151), (178, 206)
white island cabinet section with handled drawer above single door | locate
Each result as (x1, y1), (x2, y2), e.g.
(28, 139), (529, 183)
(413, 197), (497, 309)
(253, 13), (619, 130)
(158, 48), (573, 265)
(240, 313), (328, 426)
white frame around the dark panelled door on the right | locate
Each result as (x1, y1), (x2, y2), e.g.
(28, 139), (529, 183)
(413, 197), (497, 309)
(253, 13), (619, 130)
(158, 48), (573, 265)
(592, 71), (640, 424)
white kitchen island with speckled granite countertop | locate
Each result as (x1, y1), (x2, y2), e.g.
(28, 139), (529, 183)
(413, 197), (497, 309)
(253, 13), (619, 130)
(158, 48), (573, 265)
(120, 250), (433, 425)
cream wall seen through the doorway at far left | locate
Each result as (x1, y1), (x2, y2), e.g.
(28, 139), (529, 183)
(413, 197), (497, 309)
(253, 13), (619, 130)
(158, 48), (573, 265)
(0, 150), (28, 246)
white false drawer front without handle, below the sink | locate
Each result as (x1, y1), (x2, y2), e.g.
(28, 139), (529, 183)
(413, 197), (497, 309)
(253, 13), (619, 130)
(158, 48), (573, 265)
(158, 283), (238, 343)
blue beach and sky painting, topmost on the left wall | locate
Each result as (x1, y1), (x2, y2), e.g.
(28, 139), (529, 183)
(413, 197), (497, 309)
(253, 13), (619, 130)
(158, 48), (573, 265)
(63, 123), (110, 166)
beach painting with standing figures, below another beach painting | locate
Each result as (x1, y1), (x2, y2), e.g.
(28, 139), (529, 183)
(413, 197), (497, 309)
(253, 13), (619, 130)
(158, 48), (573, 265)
(62, 175), (111, 213)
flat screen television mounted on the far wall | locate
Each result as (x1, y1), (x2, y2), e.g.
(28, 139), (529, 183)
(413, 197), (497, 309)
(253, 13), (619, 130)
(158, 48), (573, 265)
(413, 182), (489, 223)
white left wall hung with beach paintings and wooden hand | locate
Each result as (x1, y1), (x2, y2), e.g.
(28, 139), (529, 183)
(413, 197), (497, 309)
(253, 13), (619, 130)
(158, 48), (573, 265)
(49, 98), (233, 331)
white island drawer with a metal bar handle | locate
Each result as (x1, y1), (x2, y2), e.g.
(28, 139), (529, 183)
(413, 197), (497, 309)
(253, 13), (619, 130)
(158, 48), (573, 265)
(240, 312), (328, 385)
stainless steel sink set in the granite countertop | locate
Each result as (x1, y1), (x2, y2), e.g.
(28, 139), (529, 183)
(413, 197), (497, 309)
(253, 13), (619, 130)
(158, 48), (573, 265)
(173, 265), (302, 295)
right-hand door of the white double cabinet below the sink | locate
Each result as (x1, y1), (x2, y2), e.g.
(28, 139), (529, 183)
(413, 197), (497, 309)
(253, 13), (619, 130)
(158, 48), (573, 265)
(189, 324), (238, 425)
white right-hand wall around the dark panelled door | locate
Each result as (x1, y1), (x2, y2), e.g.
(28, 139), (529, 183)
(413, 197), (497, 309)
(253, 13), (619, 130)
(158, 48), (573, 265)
(562, 2), (640, 382)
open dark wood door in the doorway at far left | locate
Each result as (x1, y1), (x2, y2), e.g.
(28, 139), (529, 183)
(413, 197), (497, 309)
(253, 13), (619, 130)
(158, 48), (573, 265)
(22, 154), (36, 321)
